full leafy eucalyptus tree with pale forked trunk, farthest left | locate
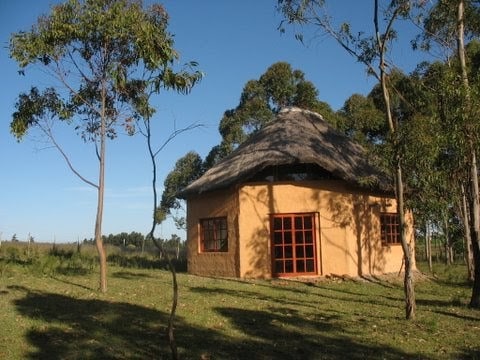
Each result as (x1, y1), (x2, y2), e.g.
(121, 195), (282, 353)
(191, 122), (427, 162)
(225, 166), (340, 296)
(9, 0), (201, 292)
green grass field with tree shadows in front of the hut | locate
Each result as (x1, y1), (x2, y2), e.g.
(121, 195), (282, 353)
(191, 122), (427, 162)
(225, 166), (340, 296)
(0, 248), (480, 359)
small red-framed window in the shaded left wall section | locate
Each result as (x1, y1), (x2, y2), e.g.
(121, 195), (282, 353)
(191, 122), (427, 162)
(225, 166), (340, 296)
(200, 217), (228, 252)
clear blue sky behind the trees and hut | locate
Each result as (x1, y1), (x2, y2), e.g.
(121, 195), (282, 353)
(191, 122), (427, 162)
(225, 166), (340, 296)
(0, 0), (428, 242)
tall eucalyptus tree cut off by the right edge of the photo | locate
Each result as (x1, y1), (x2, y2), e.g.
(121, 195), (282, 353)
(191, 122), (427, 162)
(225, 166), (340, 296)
(417, 0), (480, 308)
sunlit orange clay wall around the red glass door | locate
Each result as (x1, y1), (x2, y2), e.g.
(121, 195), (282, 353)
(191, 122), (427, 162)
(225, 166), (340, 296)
(238, 181), (414, 277)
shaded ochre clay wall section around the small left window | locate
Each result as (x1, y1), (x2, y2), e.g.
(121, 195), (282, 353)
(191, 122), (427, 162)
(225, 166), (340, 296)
(187, 190), (240, 277)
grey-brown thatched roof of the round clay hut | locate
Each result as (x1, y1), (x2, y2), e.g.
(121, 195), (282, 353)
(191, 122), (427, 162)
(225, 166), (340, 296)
(179, 108), (390, 198)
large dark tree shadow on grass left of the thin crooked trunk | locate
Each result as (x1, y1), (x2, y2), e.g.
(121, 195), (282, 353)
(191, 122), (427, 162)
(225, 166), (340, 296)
(12, 287), (169, 359)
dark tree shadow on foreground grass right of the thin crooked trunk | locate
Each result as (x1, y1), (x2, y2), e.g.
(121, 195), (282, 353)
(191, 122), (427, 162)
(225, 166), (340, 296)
(212, 307), (412, 360)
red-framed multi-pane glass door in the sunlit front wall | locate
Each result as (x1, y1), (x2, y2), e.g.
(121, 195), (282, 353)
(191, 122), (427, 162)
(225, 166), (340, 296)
(270, 213), (317, 277)
